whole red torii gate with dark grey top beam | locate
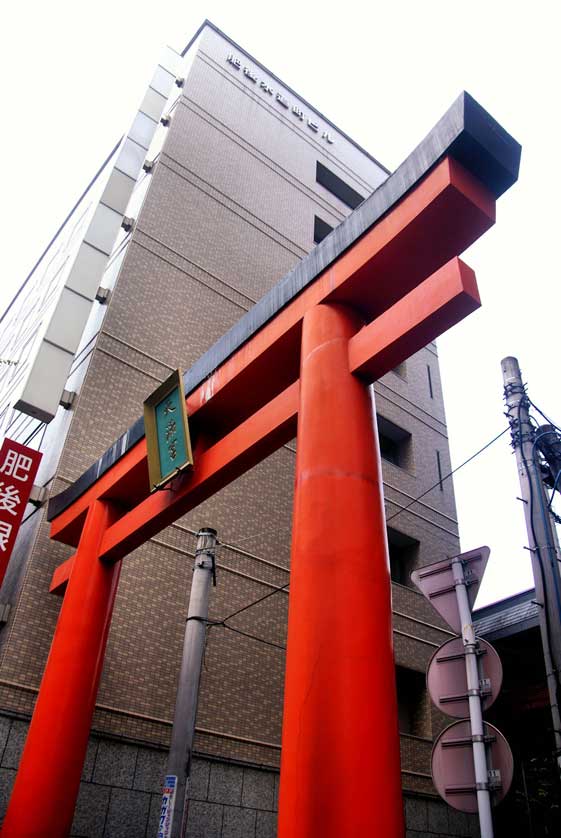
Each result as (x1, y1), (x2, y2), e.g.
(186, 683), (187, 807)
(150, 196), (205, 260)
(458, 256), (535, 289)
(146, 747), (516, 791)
(2, 94), (520, 838)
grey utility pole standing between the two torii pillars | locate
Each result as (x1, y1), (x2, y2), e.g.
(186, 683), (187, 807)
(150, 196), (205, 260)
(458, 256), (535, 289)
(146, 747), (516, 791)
(158, 527), (217, 838)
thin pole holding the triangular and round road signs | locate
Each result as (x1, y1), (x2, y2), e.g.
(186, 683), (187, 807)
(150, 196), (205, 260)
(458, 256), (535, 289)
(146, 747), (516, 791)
(452, 557), (493, 838)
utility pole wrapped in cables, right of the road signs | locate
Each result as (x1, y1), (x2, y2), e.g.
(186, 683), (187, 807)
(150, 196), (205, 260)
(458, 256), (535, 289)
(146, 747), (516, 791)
(501, 358), (561, 772)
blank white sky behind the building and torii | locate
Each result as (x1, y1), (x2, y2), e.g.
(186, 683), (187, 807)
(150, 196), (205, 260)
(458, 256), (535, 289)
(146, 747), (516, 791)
(0, 0), (561, 604)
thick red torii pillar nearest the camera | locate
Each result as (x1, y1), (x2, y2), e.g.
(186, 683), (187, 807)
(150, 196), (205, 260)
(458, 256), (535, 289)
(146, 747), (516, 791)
(278, 305), (404, 838)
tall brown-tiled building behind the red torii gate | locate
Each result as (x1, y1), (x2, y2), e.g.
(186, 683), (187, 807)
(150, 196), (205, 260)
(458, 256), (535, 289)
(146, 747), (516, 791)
(0, 23), (477, 838)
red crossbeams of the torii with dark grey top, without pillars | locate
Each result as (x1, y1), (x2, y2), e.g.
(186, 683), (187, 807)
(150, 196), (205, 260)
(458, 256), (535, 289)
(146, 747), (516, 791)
(49, 94), (519, 576)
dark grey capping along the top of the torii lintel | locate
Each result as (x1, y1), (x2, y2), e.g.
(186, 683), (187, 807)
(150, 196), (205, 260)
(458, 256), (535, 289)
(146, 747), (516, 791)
(48, 92), (521, 520)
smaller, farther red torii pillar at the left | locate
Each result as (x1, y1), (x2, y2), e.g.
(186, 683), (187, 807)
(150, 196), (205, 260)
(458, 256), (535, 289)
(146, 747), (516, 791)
(2, 500), (121, 838)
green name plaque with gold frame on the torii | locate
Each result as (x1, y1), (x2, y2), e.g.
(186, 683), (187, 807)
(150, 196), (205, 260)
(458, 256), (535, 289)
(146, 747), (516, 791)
(144, 370), (193, 492)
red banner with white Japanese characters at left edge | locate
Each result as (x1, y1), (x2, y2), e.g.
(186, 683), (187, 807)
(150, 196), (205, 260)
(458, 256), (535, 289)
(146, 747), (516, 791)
(0, 439), (43, 585)
